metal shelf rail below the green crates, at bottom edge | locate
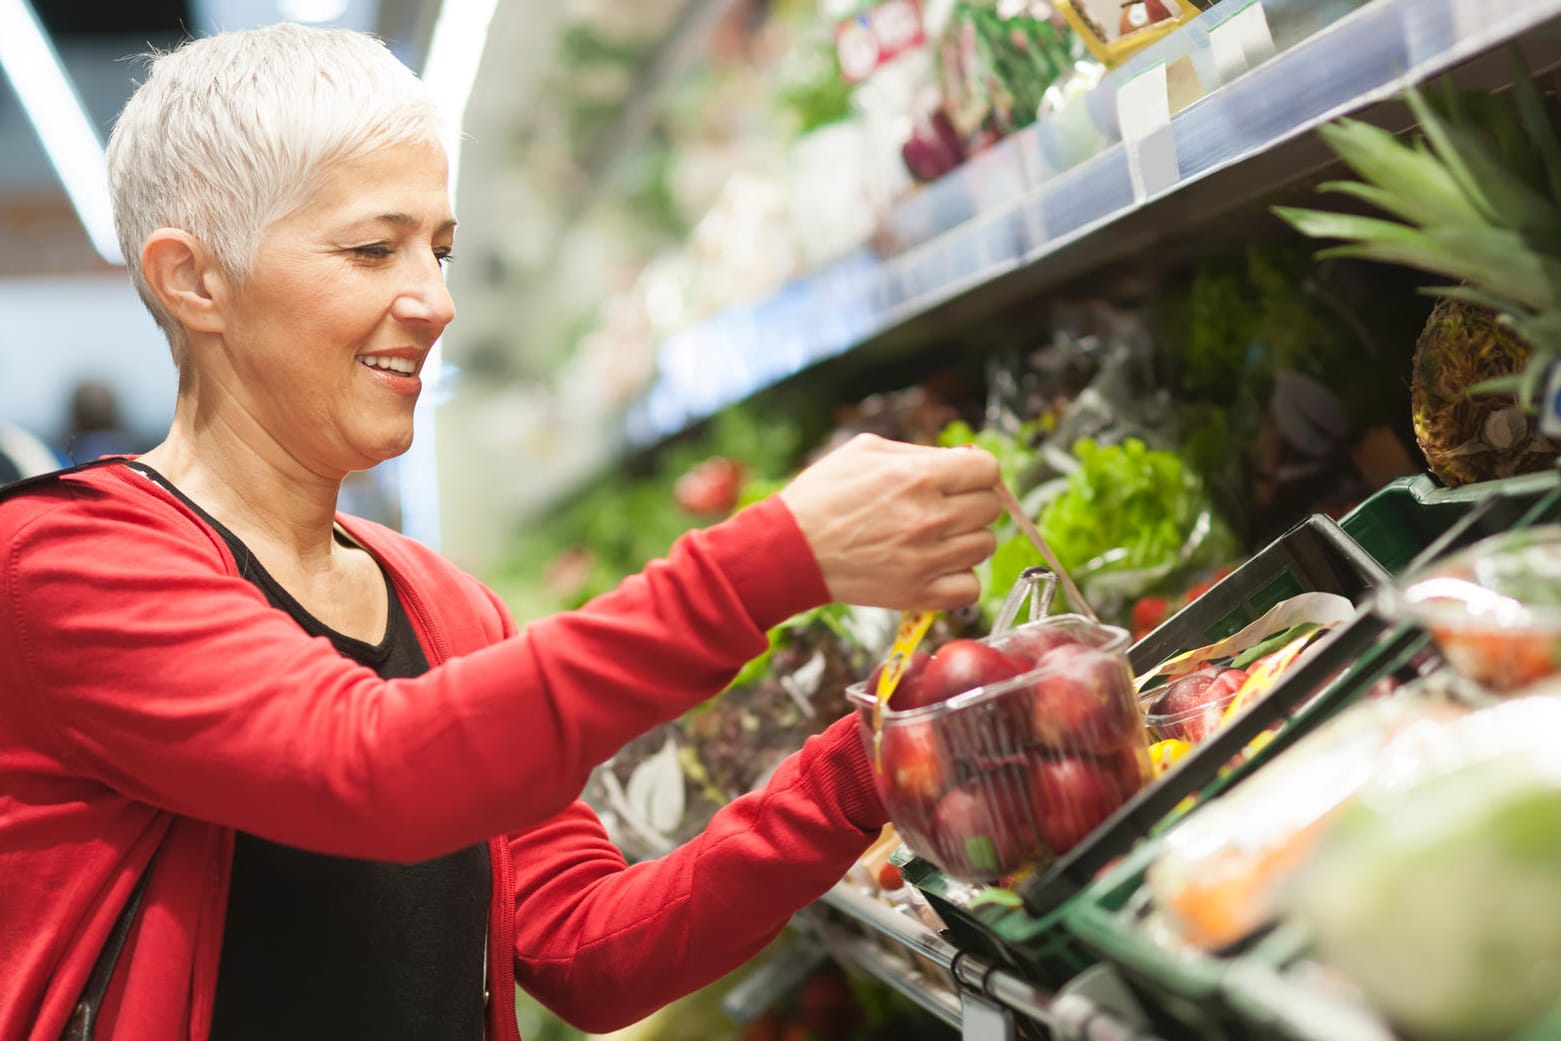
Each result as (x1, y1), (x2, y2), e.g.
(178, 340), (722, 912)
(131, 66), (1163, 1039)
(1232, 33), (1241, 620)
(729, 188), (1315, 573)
(809, 882), (1160, 1041)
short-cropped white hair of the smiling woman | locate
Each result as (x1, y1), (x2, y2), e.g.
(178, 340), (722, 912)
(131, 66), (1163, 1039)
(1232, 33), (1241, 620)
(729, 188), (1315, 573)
(108, 22), (442, 361)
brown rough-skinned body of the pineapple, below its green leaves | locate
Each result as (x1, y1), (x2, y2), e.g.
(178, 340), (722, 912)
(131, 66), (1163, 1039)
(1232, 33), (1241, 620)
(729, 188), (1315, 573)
(1410, 300), (1561, 487)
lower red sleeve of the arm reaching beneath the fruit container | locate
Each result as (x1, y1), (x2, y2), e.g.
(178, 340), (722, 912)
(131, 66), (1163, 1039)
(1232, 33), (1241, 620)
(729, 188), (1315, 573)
(510, 716), (888, 1033)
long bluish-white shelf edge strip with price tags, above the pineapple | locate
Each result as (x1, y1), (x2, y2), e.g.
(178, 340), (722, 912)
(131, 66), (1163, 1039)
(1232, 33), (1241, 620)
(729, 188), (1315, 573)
(624, 0), (1561, 448)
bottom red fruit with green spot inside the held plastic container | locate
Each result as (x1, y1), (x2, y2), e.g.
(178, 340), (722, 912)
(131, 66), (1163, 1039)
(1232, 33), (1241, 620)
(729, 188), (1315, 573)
(932, 769), (1038, 879)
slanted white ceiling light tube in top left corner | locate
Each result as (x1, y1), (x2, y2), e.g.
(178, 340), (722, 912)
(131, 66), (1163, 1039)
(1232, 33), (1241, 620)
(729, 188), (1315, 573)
(0, 0), (125, 264)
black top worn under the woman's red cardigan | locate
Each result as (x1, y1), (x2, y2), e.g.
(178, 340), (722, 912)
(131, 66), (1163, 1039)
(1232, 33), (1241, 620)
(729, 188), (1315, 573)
(130, 462), (492, 1041)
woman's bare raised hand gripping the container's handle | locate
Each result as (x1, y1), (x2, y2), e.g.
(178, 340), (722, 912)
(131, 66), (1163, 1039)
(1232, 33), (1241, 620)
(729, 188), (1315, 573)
(781, 434), (1002, 610)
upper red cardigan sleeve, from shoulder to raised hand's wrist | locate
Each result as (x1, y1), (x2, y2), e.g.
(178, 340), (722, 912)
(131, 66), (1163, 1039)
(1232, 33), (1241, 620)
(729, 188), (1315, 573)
(0, 490), (824, 860)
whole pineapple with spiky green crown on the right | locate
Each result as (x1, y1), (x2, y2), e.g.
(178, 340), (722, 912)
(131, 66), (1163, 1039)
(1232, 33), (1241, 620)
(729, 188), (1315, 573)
(1275, 52), (1561, 484)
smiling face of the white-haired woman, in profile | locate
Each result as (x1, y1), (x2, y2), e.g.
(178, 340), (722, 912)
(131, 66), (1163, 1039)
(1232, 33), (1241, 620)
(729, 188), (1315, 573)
(213, 145), (456, 476)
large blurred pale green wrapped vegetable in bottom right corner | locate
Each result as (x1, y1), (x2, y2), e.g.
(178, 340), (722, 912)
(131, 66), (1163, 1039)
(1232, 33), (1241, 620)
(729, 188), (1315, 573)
(1291, 696), (1561, 1041)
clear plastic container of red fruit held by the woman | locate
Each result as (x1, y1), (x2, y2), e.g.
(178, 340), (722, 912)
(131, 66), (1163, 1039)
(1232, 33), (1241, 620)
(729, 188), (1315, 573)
(846, 605), (1150, 882)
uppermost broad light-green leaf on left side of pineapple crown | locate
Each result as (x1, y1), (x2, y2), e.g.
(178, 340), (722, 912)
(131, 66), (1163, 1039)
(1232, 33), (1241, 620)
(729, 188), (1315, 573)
(1317, 119), (1483, 225)
